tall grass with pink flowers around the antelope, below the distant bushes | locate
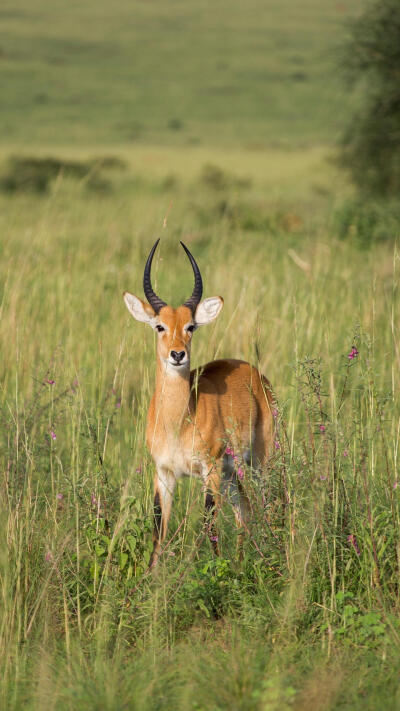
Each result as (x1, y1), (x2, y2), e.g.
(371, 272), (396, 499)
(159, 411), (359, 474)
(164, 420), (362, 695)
(0, 153), (400, 711)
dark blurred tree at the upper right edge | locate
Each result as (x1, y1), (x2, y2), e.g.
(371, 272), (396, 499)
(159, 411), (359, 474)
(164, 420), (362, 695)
(342, 0), (400, 196)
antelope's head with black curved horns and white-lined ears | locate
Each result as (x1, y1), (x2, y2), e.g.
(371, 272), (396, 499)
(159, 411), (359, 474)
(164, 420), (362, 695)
(124, 239), (224, 375)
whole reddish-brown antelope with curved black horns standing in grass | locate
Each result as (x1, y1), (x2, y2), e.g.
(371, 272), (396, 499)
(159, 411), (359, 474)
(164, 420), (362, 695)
(124, 240), (273, 566)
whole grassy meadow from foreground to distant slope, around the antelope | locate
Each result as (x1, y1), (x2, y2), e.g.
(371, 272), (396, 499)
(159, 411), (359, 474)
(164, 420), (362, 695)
(0, 0), (400, 711)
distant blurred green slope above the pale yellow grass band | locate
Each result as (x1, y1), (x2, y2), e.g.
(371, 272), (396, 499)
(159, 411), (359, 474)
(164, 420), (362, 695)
(0, 0), (362, 148)
